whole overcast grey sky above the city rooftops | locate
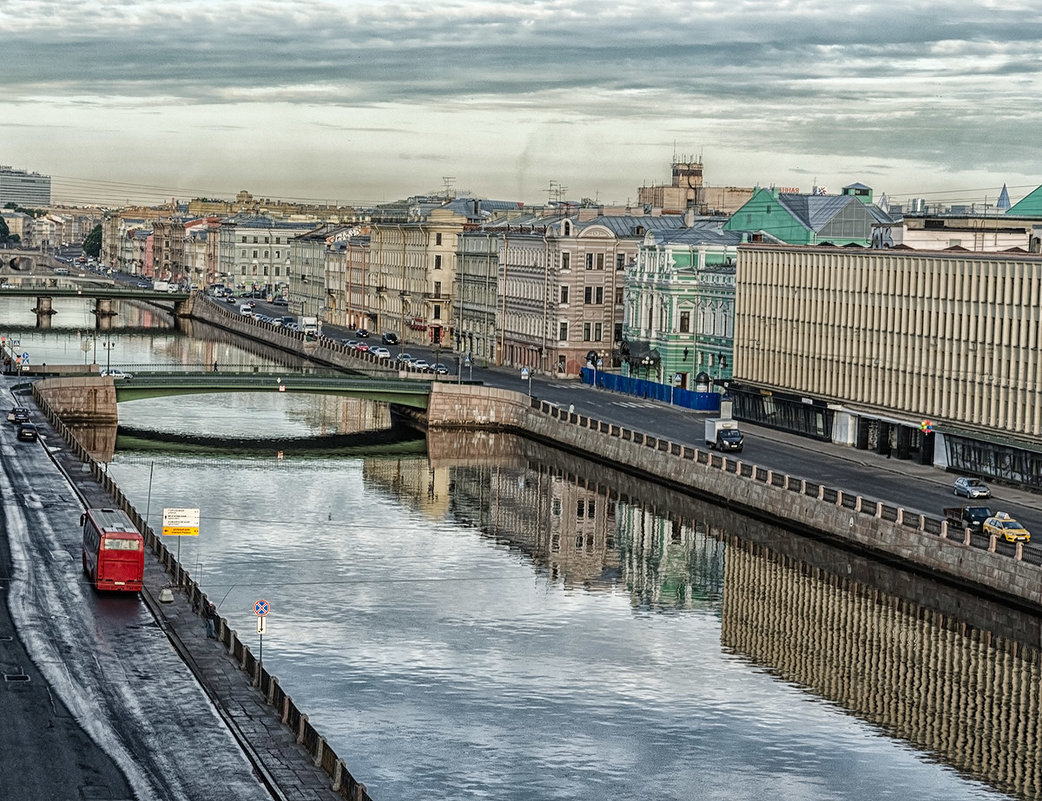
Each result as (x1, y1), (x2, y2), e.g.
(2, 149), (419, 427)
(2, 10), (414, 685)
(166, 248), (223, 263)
(0, 0), (1042, 204)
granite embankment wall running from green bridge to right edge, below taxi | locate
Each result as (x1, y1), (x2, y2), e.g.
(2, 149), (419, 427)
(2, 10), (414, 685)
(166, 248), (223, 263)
(427, 383), (1042, 610)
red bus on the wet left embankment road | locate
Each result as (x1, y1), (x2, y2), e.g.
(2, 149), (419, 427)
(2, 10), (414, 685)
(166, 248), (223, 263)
(79, 509), (145, 593)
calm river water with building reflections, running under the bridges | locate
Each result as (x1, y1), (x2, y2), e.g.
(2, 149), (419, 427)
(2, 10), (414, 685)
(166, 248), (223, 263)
(6, 295), (1042, 801)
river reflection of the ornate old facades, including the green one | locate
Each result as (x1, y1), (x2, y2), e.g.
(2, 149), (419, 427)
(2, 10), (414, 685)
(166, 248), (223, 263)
(418, 432), (723, 608)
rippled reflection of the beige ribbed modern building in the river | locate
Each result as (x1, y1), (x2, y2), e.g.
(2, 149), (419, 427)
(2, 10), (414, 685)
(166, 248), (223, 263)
(722, 537), (1042, 799)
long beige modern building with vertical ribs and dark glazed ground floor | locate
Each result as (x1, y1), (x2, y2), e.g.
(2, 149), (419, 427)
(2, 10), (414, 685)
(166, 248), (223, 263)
(728, 244), (1042, 486)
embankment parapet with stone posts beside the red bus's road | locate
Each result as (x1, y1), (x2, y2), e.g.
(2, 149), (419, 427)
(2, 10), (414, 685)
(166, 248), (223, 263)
(34, 378), (370, 801)
